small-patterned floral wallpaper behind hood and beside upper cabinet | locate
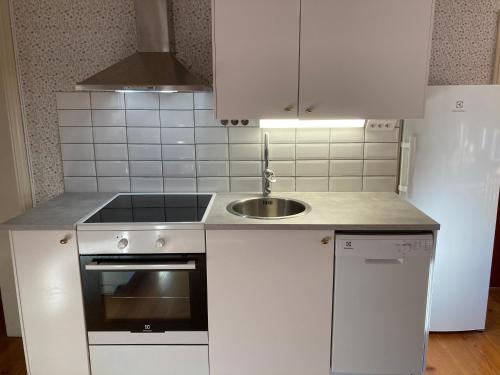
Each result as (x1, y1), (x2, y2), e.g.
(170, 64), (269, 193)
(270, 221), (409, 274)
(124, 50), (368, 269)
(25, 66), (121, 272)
(10, 0), (497, 202)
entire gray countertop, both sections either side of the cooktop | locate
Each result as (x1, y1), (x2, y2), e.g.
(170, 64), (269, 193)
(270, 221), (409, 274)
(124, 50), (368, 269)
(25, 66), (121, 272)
(0, 192), (439, 231)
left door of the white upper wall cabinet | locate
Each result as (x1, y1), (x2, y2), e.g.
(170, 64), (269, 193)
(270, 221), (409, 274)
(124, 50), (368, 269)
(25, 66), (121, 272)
(212, 0), (300, 119)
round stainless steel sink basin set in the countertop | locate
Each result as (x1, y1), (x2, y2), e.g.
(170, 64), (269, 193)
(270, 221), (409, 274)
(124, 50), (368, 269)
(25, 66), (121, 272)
(227, 197), (311, 219)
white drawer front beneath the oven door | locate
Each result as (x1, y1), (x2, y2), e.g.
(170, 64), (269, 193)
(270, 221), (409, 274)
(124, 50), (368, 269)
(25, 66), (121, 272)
(90, 345), (208, 375)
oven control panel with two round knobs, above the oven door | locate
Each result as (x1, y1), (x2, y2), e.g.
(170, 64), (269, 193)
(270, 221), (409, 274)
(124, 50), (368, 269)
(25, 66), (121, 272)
(78, 229), (205, 254)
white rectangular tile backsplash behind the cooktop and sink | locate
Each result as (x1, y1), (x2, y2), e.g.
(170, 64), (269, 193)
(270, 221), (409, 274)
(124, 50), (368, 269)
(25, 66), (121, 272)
(56, 92), (400, 192)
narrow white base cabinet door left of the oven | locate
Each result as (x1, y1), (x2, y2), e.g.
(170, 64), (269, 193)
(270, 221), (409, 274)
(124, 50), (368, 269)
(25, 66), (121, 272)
(11, 231), (90, 375)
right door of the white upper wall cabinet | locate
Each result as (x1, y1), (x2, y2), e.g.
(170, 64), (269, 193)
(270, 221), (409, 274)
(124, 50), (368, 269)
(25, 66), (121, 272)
(299, 0), (433, 119)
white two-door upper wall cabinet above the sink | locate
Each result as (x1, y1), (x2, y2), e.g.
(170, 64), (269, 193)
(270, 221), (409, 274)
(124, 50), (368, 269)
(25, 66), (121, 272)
(213, 0), (433, 119)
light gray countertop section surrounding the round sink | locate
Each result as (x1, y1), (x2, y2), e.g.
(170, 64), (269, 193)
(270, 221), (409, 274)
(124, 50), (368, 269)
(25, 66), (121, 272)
(205, 192), (440, 231)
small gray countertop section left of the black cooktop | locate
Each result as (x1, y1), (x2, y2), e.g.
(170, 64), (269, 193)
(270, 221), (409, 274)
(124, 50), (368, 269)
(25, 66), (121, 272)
(0, 193), (116, 230)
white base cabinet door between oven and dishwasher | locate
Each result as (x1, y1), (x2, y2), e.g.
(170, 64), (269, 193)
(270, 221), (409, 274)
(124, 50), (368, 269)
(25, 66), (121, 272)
(207, 230), (334, 375)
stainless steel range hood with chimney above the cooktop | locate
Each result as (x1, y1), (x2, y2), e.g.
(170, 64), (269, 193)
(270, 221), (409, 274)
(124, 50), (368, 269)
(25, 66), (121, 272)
(75, 0), (211, 92)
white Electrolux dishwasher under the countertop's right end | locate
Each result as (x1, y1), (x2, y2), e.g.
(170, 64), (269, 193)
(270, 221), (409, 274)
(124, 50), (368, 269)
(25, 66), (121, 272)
(332, 234), (434, 375)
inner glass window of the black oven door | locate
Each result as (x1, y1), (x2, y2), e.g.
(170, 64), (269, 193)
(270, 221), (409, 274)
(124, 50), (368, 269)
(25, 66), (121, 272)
(100, 271), (191, 320)
